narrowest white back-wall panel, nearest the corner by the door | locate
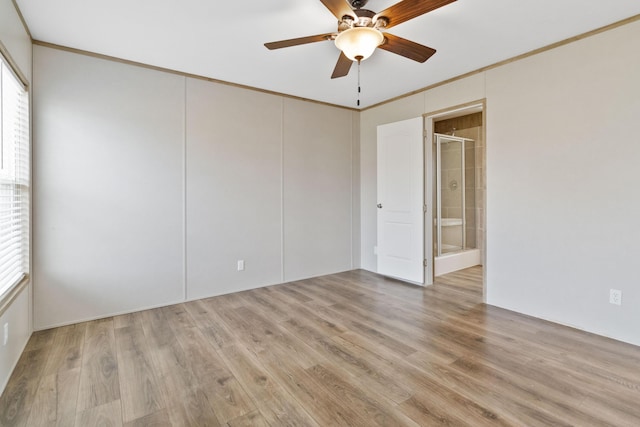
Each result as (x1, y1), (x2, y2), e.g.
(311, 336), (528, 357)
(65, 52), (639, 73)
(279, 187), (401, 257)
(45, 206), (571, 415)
(283, 99), (353, 281)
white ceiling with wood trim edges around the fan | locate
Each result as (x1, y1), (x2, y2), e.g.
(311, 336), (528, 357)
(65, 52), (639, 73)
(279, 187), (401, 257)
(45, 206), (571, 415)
(17, 0), (640, 108)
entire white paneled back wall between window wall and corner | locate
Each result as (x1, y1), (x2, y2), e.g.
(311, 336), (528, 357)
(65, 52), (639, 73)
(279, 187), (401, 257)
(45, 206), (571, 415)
(34, 46), (359, 329)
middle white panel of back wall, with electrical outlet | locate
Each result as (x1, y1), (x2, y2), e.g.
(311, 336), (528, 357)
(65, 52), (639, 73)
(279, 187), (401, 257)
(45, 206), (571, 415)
(187, 79), (283, 299)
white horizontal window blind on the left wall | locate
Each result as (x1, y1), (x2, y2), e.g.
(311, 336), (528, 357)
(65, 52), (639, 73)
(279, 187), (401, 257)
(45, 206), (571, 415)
(0, 55), (29, 295)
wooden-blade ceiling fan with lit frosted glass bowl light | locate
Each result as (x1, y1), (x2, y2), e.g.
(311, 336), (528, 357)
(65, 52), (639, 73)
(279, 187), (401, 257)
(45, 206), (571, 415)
(264, 0), (456, 79)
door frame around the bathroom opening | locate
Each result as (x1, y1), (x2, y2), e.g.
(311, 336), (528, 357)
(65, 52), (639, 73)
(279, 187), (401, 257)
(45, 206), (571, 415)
(423, 98), (489, 303)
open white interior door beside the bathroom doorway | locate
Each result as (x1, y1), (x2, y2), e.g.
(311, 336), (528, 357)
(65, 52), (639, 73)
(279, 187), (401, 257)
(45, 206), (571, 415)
(378, 117), (425, 284)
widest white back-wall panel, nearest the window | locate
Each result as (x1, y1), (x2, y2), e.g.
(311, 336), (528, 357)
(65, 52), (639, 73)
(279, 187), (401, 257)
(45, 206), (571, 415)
(33, 46), (185, 329)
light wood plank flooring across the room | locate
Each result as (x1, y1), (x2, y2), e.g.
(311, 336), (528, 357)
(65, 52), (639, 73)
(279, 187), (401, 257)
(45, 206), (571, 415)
(0, 267), (640, 427)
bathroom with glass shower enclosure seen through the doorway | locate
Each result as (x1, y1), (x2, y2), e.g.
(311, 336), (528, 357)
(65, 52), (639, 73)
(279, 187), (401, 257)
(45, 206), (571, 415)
(433, 110), (486, 276)
